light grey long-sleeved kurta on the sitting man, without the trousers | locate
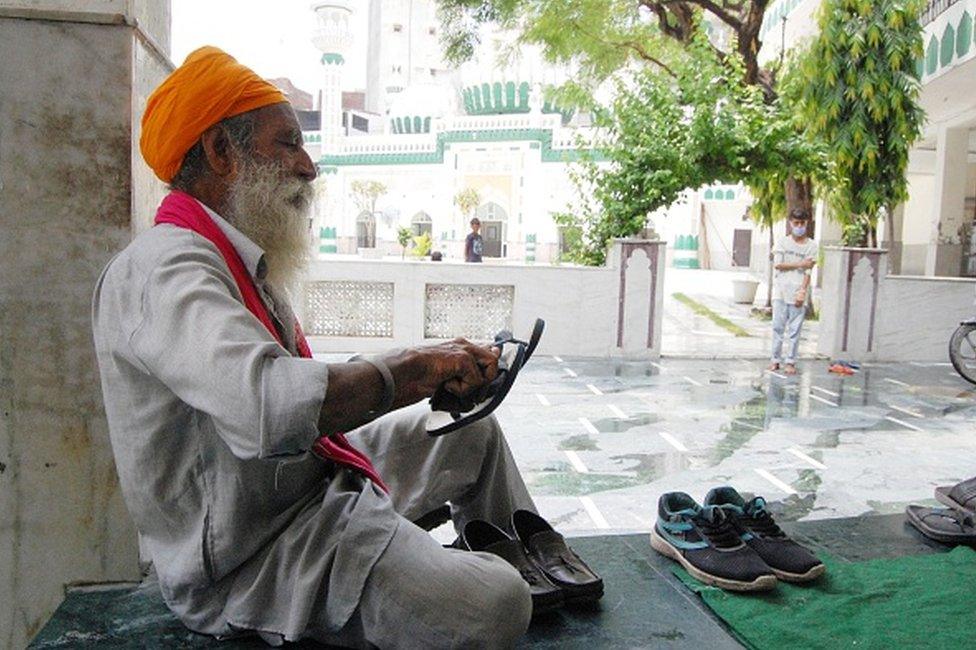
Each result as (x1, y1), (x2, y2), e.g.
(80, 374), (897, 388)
(94, 212), (397, 638)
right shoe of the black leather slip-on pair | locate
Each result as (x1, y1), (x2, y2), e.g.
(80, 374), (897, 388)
(512, 510), (603, 604)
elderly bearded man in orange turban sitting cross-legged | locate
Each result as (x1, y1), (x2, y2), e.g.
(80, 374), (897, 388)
(94, 47), (602, 648)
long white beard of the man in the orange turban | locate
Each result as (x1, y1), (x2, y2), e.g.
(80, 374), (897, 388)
(227, 157), (314, 292)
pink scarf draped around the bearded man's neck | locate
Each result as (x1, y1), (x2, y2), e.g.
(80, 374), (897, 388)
(156, 190), (390, 492)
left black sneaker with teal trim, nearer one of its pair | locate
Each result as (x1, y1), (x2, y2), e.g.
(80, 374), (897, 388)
(651, 492), (776, 591)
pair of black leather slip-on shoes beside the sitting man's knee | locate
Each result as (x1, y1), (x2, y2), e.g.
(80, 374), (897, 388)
(456, 510), (603, 616)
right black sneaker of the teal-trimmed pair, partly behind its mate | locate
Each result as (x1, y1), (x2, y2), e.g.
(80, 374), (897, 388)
(705, 486), (826, 582)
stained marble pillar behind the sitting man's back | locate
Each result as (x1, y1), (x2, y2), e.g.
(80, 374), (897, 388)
(0, 0), (171, 648)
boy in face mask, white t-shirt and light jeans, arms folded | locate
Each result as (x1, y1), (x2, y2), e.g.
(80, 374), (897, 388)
(769, 209), (817, 375)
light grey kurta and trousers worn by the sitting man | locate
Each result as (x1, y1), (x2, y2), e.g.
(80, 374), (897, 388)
(94, 205), (535, 650)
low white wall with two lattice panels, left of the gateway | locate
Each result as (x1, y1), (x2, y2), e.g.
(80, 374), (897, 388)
(298, 242), (664, 357)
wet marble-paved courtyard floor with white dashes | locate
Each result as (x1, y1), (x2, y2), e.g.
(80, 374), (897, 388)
(470, 357), (976, 540)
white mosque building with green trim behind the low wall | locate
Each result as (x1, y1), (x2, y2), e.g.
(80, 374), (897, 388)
(292, 0), (764, 268)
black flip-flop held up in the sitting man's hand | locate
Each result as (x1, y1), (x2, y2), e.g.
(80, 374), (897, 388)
(427, 318), (546, 436)
